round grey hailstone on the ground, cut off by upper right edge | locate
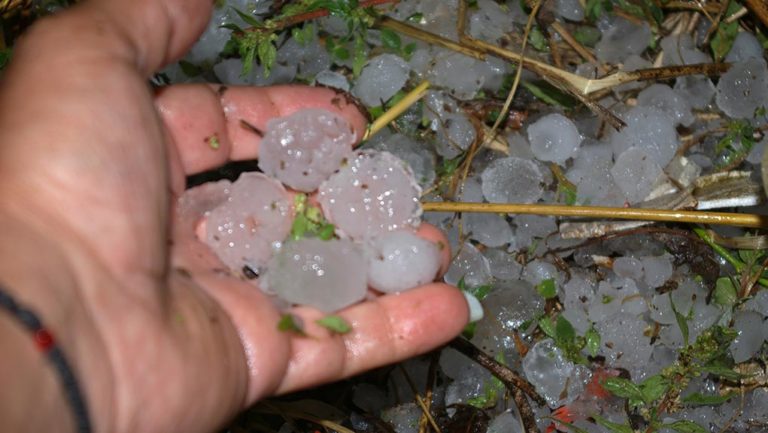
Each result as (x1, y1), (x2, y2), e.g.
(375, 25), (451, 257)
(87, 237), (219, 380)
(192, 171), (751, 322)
(715, 57), (768, 119)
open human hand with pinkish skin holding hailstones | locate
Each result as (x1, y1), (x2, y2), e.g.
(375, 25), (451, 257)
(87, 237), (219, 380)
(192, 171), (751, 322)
(0, 0), (468, 432)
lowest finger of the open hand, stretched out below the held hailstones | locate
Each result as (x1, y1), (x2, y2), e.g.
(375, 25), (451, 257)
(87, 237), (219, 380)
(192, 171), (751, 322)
(275, 283), (469, 394)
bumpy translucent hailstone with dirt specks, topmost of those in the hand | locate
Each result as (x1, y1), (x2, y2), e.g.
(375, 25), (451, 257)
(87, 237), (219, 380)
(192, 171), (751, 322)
(259, 109), (355, 192)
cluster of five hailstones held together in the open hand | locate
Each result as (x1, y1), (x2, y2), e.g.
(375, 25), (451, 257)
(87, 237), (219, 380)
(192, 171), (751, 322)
(198, 109), (440, 313)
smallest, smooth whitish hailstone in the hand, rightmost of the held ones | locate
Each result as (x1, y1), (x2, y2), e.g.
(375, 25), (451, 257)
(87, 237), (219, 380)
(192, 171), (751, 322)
(368, 230), (440, 293)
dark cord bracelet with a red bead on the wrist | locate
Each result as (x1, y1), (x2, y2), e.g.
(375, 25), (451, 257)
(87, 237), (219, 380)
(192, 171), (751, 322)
(0, 287), (92, 433)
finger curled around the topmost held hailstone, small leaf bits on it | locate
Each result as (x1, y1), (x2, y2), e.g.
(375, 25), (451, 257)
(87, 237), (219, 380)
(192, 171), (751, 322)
(156, 84), (367, 174)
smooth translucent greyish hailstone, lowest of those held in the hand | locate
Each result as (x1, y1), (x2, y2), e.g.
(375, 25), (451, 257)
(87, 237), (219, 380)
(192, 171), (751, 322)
(262, 238), (368, 313)
